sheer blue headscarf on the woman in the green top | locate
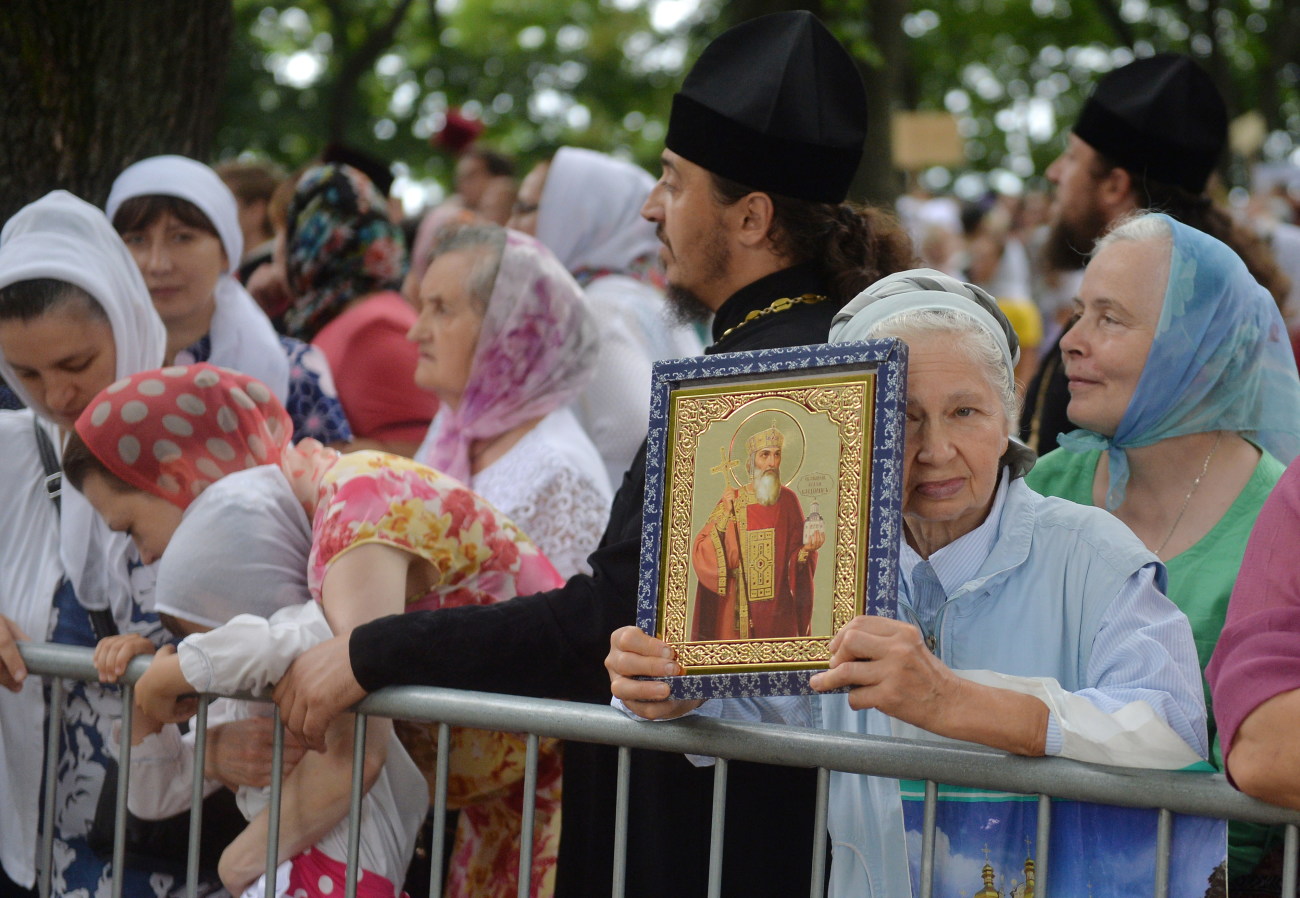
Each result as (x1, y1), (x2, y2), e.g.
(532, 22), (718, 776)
(1060, 213), (1300, 511)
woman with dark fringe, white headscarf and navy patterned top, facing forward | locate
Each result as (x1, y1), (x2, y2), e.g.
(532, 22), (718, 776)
(107, 156), (352, 444)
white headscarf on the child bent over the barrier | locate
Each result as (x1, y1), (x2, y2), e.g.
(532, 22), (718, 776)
(153, 465), (312, 626)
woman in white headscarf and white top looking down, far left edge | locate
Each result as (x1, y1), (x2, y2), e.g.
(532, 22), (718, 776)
(0, 191), (302, 895)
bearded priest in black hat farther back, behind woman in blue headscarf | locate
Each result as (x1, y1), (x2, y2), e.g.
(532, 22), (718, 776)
(1021, 53), (1290, 455)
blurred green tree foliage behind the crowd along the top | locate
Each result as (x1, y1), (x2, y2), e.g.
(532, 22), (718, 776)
(216, 0), (1300, 204)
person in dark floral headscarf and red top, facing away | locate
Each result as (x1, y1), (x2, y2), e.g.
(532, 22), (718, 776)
(277, 164), (438, 457)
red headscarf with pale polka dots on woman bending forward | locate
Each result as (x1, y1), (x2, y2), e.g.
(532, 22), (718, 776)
(77, 364), (294, 509)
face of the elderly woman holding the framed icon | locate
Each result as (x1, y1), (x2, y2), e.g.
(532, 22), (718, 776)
(902, 334), (1008, 556)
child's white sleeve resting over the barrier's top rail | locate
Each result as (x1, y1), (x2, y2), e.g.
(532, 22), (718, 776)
(177, 602), (334, 695)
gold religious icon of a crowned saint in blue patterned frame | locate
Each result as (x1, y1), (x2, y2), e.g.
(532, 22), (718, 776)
(638, 340), (906, 695)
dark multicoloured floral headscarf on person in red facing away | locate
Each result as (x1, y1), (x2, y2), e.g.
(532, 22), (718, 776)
(285, 164), (407, 342)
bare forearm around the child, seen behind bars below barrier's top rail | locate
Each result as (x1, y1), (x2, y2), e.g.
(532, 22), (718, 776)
(217, 715), (393, 895)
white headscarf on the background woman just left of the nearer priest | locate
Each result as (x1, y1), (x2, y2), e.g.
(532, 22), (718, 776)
(537, 147), (659, 273)
